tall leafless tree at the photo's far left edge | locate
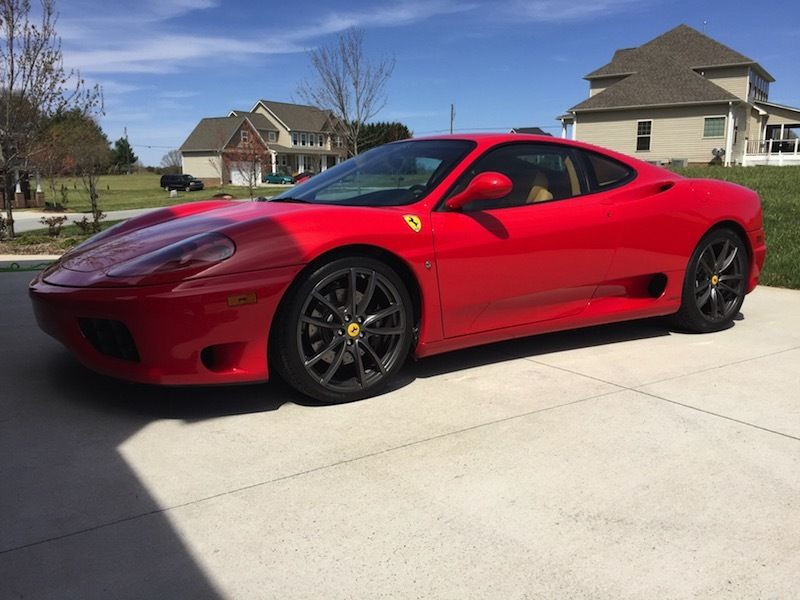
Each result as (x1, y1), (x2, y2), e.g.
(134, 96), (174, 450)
(0, 0), (102, 236)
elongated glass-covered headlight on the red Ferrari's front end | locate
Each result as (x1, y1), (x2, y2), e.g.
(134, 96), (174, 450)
(108, 233), (236, 277)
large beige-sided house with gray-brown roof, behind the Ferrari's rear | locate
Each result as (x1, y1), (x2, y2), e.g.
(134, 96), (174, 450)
(559, 25), (800, 165)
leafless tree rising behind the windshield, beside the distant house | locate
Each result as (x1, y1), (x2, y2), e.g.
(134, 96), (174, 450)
(298, 29), (395, 156)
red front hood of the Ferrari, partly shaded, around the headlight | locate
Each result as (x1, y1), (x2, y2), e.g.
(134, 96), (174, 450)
(43, 201), (418, 287)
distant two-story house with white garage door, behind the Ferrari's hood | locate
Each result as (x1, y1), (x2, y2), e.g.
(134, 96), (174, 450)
(180, 100), (346, 185)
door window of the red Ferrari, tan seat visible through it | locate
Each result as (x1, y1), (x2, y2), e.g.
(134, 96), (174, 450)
(450, 144), (587, 211)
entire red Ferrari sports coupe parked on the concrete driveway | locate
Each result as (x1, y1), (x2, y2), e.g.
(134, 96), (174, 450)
(30, 134), (766, 402)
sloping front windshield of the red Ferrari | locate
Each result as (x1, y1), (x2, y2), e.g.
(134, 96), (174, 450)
(273, 140), (475, 206)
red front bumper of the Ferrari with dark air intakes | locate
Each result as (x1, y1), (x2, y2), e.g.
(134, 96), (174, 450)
(29, 266), (301, 385)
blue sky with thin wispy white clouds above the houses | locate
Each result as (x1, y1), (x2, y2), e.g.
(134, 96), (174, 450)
(57, 0), (800, 165)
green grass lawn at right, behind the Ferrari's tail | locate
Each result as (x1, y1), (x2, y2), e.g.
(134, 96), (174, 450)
(676, 167), (800, 289)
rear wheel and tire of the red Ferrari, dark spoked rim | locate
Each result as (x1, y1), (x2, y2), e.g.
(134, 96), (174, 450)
(671, 228), (750, 333)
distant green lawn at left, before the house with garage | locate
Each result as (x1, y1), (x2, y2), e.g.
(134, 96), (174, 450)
(32, 173), (286, 212)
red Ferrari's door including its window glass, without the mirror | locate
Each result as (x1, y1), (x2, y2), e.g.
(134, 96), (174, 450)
(431, 143), (617, 337)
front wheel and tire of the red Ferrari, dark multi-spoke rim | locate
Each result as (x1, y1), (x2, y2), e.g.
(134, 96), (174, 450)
(270, 256), (412, 404)
